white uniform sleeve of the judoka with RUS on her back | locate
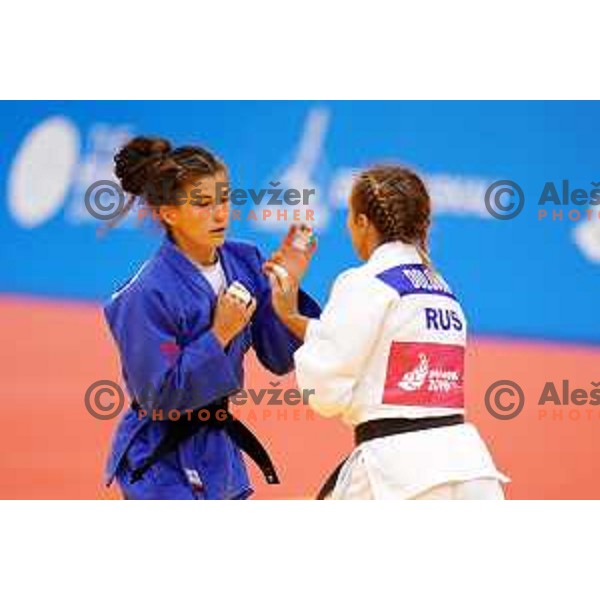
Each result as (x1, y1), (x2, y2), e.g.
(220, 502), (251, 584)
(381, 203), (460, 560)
(294, 269), (392, 417)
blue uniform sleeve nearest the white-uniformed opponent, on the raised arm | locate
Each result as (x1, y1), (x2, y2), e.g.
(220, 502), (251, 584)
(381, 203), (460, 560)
(247, 249), (321, 375)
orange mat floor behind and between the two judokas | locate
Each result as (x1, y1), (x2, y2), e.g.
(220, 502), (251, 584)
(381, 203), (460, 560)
(0, 295), (600, 499)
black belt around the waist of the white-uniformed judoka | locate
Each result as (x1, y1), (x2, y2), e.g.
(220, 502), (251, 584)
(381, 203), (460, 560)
(317, 415), (465, 500)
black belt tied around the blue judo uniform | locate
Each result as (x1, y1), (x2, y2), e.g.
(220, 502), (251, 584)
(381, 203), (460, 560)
(124, 398), (279, 484)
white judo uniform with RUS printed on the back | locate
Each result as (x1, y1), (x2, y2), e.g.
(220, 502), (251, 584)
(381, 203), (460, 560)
(294, 242), (508, 499)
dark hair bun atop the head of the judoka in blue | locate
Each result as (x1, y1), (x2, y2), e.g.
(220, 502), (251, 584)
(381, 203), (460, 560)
(115, 137), (171, 196)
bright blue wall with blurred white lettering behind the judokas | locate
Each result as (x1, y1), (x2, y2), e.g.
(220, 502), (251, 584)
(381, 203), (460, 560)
(0, 101), (600, 343)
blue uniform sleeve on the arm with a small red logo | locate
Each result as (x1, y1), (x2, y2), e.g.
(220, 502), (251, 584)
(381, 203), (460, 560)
(105, 284), (242, 418)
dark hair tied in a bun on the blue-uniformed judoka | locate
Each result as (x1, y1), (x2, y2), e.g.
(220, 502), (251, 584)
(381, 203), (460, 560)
(114, 136), (227, 233)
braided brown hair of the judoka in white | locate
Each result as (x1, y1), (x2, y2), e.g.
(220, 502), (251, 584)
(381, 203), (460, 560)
(350, 165), (431, 266)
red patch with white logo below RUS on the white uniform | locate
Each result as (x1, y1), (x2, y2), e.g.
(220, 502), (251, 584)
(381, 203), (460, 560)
(383, 342), (465, 408)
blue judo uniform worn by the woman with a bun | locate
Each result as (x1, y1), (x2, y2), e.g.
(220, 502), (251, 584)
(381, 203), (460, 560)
(105, 238), (320, 499)
